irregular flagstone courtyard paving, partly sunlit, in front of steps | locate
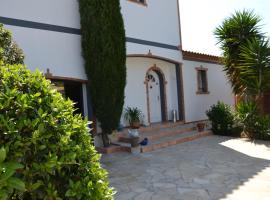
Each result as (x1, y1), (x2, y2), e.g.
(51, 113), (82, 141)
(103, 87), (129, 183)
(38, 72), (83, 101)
(102, 136), (270, 200)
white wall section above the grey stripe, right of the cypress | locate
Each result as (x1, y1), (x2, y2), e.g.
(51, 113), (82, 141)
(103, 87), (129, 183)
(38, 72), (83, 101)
(121, 0), (180, 46)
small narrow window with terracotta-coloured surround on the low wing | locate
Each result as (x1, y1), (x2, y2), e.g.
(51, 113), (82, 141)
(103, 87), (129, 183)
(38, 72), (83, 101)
(196, 67), (209, 94)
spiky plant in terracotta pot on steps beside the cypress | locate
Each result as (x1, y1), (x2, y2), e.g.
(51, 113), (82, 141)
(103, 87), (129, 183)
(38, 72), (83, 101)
(124, 107), (142, 129)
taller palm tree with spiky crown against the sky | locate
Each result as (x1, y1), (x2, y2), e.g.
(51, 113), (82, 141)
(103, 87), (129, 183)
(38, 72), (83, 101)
(214, 10), (263, 95)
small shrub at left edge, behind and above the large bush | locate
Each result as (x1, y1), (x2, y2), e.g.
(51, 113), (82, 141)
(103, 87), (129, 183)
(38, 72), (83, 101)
(0, 24), (24, 64)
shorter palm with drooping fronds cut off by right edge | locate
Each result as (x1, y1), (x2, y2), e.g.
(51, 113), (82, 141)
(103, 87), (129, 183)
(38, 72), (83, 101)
(236, 38), (270, 111)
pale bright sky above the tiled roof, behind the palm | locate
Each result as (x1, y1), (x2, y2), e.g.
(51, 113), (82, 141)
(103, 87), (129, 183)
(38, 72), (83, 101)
(179, 0), (270, 55)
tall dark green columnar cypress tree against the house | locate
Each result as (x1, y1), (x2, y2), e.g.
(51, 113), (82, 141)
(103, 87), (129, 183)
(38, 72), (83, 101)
(79, 0), (126, 147)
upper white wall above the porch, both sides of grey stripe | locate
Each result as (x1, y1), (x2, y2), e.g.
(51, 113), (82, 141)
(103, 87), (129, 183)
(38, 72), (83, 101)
(121, 0), (182, 62)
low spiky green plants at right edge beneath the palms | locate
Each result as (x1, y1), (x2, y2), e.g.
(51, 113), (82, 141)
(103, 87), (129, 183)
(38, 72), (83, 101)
(236, 102), (270, 140)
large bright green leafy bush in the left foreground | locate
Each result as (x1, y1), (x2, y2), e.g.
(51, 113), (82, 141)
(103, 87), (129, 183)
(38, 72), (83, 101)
(0, 64), (113, 200)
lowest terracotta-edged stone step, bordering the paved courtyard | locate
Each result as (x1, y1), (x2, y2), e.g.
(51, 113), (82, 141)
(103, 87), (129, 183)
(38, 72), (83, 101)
(141, 130), (212, 153)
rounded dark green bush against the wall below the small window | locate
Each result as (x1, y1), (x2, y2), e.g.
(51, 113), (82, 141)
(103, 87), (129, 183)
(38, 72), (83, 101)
(206, 102), (234, 135)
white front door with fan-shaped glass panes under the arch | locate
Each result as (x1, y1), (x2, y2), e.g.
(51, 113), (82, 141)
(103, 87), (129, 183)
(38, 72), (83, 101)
(148, 71), (162, 123)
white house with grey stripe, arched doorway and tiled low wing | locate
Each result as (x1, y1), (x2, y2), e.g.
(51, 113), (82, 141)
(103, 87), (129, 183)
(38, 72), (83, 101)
(0, 0), (234, 125)
